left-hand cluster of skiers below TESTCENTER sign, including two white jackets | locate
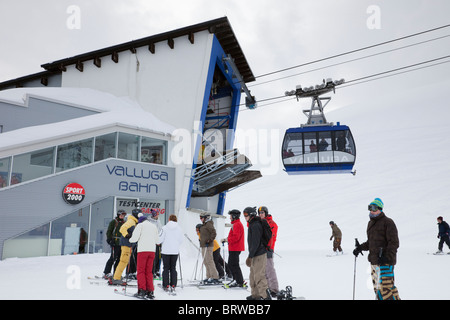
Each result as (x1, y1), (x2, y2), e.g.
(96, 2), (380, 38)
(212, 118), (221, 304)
(103, 209), (183, 299)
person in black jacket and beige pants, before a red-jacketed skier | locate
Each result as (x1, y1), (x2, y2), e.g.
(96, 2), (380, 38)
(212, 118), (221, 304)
(243, 207), (271, 300)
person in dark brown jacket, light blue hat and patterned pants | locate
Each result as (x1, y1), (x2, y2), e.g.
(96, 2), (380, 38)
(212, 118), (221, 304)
(353, 198), (400, 300)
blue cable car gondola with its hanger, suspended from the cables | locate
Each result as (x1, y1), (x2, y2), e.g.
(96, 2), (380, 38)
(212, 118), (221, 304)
(281, 79), (356, 175)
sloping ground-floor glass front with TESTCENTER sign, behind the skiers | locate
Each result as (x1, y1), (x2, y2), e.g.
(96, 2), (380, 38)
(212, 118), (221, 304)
(2, 197), (168, 259)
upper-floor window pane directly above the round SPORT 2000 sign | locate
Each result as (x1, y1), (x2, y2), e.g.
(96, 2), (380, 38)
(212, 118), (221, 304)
(56, 139), (92, 172)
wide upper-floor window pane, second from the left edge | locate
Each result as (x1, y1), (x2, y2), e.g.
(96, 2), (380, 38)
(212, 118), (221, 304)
(11, 148), (55, 185)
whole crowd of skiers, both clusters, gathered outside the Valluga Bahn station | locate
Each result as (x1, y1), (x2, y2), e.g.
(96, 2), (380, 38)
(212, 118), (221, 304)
(103, 206), (279, 300)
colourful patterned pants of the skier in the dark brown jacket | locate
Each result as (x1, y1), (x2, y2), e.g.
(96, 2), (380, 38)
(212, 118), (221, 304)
(371, 265), (400, 300)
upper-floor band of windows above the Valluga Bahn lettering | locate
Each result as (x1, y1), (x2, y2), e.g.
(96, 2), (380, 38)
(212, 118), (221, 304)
(0, 132), (167, 189)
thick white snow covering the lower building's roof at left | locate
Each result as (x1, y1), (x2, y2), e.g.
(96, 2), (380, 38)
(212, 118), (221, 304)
(0, 88), (175, 151)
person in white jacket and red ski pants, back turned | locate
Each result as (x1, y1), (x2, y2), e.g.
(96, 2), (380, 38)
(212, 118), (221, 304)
(130, 213), (159, 299)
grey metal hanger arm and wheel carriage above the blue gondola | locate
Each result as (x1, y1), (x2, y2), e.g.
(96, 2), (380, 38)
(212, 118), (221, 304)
(285, 78), (345, 127)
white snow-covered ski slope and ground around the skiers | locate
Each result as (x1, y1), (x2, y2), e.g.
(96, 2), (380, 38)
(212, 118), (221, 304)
(0, 82), (450, 300)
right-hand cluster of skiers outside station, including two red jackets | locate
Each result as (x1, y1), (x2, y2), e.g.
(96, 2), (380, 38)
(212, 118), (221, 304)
(197, 206), (279, 300)
